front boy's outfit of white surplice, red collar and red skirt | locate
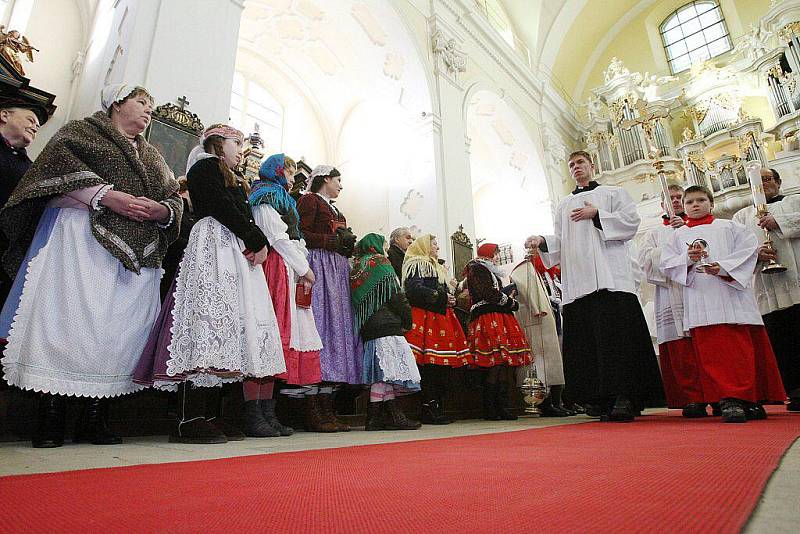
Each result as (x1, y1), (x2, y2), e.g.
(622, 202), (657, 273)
(661, 215), (785, 422)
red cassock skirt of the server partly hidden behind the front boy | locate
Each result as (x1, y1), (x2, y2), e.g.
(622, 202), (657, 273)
(658, 337), (705, 408)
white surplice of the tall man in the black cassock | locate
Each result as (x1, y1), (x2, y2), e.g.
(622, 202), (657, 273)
(541, 185), (641, 305)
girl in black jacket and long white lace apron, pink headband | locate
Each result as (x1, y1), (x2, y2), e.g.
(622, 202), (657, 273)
(140, 124), (286, 443)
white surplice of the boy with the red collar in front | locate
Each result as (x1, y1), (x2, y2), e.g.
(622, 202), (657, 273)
(661, 219), (764, 330)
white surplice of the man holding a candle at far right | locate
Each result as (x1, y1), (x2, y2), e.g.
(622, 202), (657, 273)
(733, 195), (800, 315)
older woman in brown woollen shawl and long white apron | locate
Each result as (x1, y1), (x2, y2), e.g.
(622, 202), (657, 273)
(0, 85), (183, 447)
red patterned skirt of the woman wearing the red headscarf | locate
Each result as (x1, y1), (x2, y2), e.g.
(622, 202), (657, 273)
(469, 312), (531, 367)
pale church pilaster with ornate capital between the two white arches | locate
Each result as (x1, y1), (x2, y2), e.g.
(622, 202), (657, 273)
(428, 16), (475, 264)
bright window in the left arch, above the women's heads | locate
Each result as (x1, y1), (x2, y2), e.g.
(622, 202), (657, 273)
(230, 72), (283, 152)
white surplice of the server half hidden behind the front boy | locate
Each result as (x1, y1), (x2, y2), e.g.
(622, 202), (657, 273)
(639, 226), (688, 345)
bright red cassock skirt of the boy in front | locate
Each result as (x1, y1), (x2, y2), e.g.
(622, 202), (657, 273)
(691, 324), (786, 402)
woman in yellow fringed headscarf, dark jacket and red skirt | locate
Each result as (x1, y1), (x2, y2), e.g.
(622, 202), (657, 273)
(403, 234), (471, 425)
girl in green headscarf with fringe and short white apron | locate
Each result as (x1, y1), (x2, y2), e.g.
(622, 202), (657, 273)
(350, 234), (420, 430)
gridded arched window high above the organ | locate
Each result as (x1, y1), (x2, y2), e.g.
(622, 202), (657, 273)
(659, 0), (731, 74)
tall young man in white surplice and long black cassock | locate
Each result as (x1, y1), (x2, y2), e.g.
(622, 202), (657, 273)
(532, 151), (663, 422)
